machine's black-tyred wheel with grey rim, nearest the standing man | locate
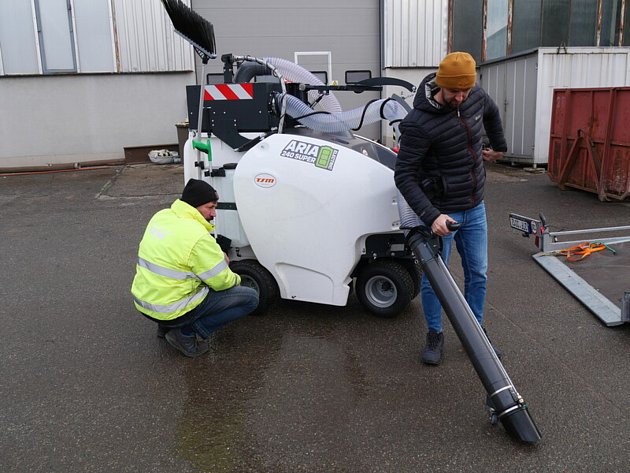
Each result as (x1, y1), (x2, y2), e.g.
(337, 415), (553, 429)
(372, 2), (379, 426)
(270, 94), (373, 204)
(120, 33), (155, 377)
(355, 259), (415, 317)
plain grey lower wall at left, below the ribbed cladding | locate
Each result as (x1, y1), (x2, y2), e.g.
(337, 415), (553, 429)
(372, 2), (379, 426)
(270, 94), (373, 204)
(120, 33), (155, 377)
(0, 73), (194, 170)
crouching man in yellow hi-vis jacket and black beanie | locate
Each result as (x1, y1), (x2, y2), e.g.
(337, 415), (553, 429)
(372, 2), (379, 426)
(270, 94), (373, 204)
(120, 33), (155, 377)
(131, 179), (258, 357)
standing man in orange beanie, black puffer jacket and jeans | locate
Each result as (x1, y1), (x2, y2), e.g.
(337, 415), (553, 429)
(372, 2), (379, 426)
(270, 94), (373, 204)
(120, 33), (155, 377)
(395, 52), (507, 365)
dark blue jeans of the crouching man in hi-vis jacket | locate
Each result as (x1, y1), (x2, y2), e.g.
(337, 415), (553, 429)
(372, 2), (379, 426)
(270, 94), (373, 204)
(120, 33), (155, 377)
(164, 286), (258, 339)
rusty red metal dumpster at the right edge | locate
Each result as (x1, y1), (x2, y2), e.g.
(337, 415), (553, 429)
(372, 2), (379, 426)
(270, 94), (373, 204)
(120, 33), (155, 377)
(547, 87), (630, 201)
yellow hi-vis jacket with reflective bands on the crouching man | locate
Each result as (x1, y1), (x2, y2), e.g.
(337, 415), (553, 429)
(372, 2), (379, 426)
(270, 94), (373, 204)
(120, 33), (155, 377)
(131, 199), (241, 320)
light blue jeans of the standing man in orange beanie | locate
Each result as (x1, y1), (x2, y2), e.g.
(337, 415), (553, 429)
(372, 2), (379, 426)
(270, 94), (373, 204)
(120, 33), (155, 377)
(421, 202), (488, 333)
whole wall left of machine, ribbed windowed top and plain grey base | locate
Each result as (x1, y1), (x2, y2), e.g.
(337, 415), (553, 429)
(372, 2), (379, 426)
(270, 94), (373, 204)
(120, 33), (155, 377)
(0, 0), (195, 169)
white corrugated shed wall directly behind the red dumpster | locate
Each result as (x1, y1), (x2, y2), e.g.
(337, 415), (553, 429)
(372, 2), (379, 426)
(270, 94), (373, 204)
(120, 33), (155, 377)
(534, 47), (630, 163)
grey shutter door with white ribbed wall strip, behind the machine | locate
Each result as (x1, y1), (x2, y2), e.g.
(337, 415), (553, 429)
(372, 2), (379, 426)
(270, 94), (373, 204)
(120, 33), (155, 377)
(192, 0), (449, 144)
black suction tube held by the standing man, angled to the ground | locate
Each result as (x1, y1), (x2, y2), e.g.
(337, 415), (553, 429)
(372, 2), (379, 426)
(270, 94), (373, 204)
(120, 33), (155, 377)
(407, 224), (541, 444)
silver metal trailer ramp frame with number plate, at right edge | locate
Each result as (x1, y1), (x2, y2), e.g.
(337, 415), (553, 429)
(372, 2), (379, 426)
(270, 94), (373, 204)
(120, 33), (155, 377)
(510, 214), (630, 327)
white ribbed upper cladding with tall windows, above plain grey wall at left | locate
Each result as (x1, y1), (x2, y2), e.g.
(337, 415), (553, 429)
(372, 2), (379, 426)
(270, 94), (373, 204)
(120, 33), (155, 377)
(0, 0), (194, 75)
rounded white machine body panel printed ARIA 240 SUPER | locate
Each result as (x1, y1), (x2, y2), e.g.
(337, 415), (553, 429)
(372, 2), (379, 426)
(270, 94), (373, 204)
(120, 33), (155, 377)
(235, 134), (399, 306)
